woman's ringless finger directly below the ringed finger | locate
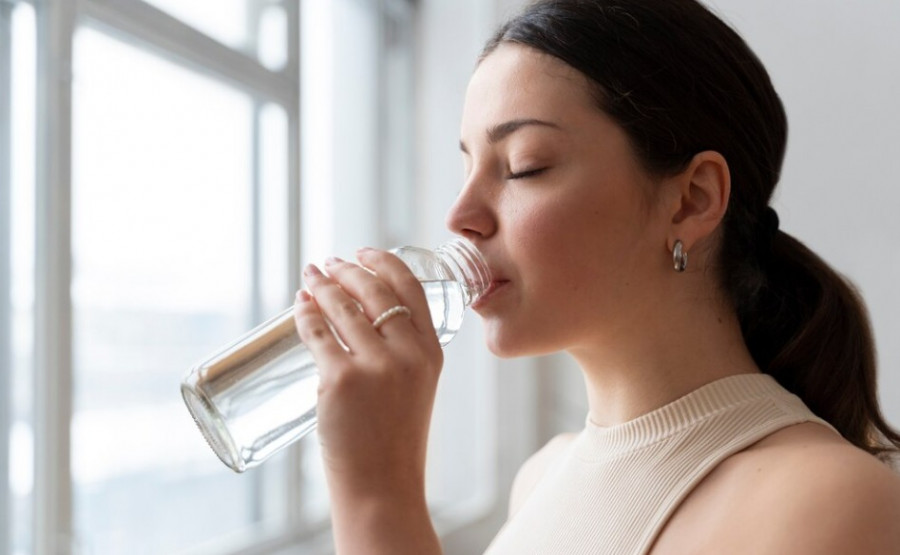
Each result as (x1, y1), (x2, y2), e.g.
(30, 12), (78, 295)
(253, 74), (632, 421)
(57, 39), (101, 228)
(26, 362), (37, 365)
(303, 264), (382, 352)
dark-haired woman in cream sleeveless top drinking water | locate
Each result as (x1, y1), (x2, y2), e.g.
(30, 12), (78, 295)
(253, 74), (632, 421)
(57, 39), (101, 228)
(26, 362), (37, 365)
(295, 0), (900, 554)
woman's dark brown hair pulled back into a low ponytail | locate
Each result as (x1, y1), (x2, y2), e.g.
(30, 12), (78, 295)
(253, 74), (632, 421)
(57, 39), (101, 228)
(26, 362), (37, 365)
(482, 0), (900, 457)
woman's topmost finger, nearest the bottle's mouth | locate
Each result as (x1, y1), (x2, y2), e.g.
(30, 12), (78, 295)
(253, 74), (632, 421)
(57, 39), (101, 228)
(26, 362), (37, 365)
(356, 249), (434, 335)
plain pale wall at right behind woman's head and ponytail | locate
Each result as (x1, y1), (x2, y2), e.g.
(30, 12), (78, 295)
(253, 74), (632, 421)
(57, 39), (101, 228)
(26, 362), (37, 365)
(711, 0), (900, 427)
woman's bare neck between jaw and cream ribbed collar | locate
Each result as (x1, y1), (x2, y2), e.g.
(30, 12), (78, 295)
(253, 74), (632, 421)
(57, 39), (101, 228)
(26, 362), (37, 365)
(569, 282), (759, 426)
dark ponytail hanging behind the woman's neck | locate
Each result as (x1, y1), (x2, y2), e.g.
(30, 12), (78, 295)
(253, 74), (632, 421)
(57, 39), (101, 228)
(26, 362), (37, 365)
(733, 232), (900, 459)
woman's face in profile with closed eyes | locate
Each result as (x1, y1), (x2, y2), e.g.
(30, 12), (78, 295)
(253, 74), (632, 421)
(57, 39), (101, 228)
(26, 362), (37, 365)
(447, 44), (671, 356)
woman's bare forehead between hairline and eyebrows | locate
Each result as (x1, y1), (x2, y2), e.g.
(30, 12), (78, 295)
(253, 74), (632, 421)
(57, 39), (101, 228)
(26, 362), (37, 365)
(462, 43), (599, 136)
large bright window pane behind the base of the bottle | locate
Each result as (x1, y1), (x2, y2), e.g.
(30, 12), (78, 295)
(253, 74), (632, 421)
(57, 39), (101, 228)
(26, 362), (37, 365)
(71, 27), (284, 554)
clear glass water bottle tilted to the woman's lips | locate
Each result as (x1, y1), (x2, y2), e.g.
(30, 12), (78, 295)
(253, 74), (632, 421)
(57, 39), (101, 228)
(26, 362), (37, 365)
(181, 238), (491, 472)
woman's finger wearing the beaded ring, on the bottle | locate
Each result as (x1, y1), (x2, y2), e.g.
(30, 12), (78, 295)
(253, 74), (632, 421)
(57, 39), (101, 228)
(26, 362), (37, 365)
(325, 258), (416, 335)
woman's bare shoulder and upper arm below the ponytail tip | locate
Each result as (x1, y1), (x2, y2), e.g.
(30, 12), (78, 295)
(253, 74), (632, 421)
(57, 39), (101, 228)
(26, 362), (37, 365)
(653, 423), (900, 555)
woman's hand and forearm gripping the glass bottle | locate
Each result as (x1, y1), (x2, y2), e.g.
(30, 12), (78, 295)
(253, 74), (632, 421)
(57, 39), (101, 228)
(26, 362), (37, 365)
(294, 249), (443, 553)
